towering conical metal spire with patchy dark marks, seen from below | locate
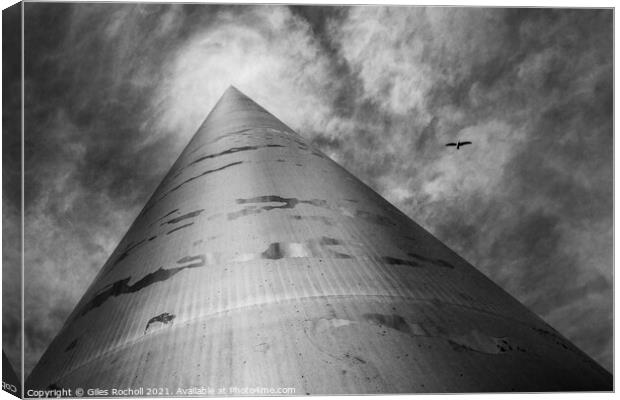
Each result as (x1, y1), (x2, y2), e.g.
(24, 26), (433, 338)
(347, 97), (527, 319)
(26, 87), (612, 395)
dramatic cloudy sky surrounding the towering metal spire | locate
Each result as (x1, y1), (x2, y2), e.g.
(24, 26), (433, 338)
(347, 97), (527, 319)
(3, 3), (613, 375)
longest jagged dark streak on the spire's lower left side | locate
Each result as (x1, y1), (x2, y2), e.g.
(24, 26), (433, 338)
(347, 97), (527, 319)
(79, 254), (206, 316)
